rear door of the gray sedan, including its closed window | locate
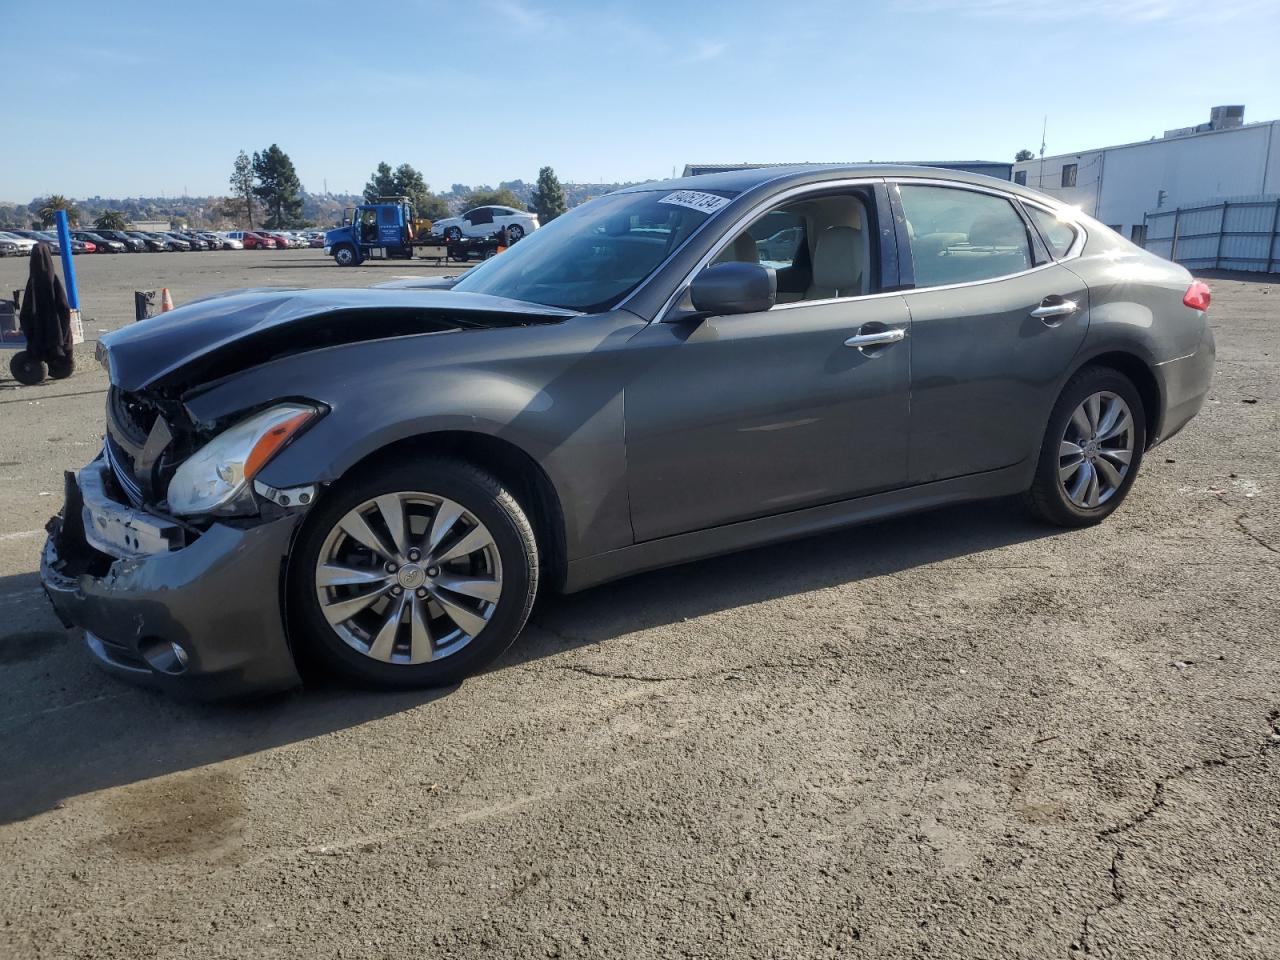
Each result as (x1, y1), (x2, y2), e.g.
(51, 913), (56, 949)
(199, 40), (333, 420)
(896, 179), (1089, 484)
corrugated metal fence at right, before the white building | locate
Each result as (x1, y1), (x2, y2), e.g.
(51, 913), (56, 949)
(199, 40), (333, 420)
(1142, 197), (1280, 273)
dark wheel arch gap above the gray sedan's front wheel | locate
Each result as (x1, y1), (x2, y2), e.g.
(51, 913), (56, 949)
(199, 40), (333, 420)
(327, 430), (568, 590)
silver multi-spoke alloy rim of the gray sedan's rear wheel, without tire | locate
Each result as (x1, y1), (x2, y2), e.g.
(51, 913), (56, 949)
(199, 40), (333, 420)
(1059, 390), (1134, 509)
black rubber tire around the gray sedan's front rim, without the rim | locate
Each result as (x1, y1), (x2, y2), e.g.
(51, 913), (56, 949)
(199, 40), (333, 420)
(288, 458), (539, 690)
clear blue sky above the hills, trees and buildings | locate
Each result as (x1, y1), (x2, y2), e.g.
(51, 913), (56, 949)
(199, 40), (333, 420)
(0, 0), (1280, 201)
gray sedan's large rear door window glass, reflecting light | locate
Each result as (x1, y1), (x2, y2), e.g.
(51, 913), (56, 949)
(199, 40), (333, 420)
(901, 184), (1032, 287)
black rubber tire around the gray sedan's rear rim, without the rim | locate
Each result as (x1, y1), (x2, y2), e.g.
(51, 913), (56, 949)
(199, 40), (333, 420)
(1024, 366), (1147, 527)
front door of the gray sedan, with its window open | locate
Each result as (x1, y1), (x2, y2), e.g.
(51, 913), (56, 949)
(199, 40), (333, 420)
(626, 180), (910, 540)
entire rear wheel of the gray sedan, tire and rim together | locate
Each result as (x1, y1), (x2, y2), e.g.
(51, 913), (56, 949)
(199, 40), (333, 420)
(1027, 366), (1147, 527)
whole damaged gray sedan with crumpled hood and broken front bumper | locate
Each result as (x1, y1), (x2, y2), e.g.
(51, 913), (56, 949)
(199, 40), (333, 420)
(41, 166), (1213, 696)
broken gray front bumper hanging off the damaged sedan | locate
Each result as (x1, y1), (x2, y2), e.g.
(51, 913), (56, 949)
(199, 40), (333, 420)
(40, 457), (301, 699)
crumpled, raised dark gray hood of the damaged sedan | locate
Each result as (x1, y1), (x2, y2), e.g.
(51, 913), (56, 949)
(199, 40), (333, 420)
(99, 287), (576, 392)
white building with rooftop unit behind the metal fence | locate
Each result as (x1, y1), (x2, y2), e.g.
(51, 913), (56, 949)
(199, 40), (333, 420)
(1014, 106), (1280, 243)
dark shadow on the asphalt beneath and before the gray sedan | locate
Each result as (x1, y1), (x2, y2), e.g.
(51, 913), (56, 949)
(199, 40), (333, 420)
(0, 500), (1056, 823)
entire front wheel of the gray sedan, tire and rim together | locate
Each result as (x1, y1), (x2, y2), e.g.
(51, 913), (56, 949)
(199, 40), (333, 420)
(289, 458), (539, 689)
